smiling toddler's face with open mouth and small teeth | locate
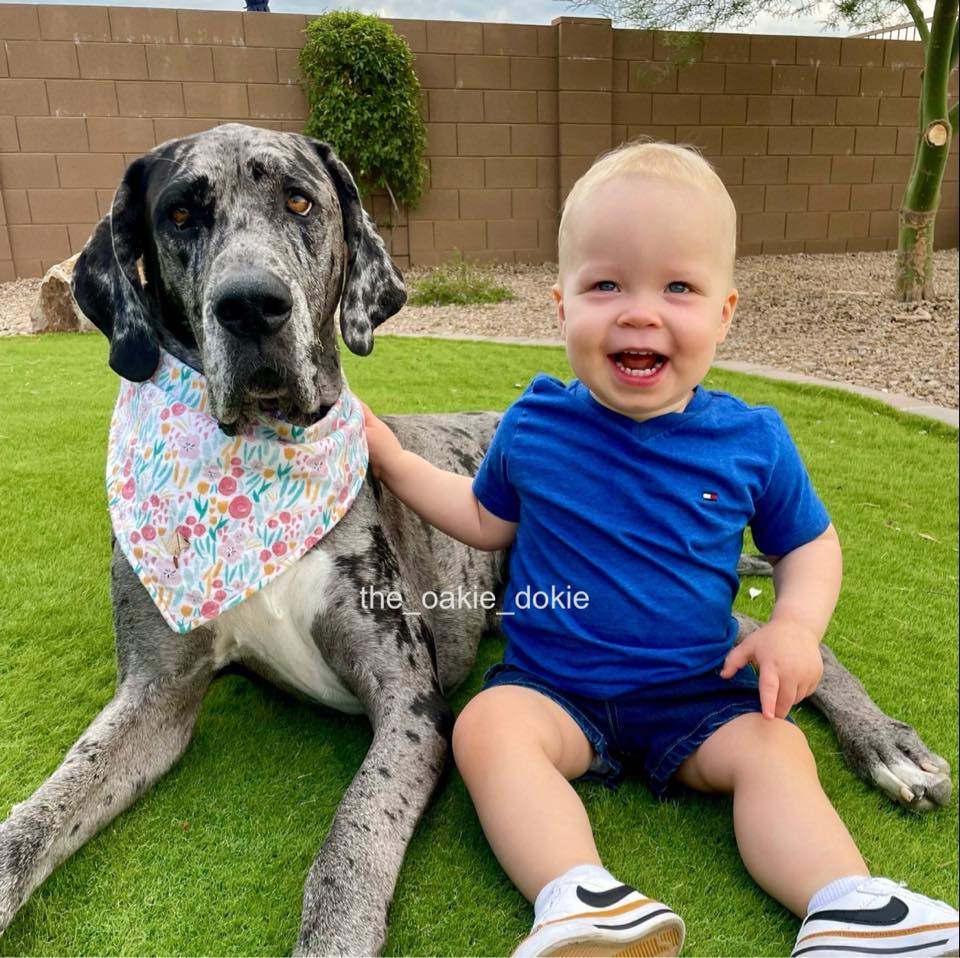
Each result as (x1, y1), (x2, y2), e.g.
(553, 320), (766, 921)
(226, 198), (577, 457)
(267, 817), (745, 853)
(553, 175), (737, 419)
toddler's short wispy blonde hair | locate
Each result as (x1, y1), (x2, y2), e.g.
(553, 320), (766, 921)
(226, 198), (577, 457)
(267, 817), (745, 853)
(558, 140), (737, 277)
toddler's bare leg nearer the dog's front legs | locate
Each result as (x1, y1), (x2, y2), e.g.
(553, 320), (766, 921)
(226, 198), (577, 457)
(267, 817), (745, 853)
(453, 685), (600, 901)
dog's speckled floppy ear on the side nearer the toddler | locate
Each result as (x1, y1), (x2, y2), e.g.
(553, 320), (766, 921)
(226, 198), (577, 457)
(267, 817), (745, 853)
(313, 140), (407, 356)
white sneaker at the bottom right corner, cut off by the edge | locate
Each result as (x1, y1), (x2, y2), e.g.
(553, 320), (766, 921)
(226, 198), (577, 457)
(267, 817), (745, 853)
(793, 878), (960, 958)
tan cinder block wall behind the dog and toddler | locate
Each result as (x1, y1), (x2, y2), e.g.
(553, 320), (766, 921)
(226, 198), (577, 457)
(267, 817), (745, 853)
(0, 4), (958, 281)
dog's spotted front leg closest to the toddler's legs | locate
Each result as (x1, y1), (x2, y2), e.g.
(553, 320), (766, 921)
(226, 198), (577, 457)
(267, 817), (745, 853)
(294, 663), (451, 955)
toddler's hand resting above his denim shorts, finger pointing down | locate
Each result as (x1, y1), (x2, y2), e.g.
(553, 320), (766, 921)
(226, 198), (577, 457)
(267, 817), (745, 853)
(720, 619), (823, 718)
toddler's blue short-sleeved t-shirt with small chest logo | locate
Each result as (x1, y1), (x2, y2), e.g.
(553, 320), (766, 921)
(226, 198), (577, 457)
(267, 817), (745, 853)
(473, 376), (830, 698)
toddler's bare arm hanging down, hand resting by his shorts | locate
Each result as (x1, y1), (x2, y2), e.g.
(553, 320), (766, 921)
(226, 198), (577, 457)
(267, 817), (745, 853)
(720, 524), (843, 718)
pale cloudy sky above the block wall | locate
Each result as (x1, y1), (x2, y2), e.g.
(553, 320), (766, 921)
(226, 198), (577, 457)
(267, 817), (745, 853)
(0, 0), (933, 36)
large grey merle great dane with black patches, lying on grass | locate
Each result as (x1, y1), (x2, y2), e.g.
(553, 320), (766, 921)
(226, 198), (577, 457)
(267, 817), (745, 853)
(0, 124), (950, 955)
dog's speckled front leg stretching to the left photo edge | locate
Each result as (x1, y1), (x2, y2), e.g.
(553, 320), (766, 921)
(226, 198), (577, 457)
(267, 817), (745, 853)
(0, 560), (213, 932)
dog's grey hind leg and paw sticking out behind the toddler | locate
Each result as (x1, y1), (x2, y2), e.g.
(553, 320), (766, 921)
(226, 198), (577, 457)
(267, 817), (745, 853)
(736, 614), (951, 811)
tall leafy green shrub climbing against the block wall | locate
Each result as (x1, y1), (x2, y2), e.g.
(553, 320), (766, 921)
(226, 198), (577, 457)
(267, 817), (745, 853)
(300, 10), (427, 206)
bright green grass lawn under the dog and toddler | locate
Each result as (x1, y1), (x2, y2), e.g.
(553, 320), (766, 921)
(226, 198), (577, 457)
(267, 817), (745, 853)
(0, 336), (958, 955)
